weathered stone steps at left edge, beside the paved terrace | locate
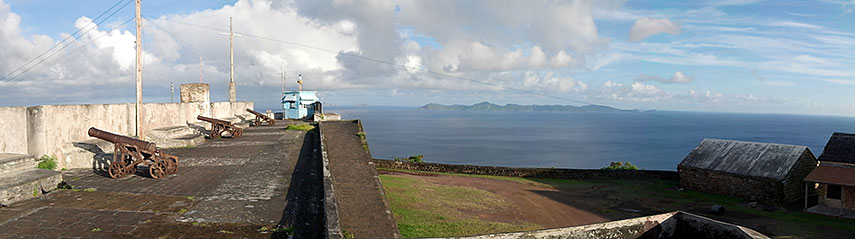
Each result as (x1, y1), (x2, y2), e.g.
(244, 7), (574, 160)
(0, 153), (62, 205)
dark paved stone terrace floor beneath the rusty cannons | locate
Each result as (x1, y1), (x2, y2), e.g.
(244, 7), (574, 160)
(0, 124), (324, 238)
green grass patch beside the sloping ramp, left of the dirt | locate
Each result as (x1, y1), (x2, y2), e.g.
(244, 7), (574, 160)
(380, 175), (541, 237)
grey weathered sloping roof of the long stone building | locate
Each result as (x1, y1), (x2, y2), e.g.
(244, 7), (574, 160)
(678, 139), (813, 180)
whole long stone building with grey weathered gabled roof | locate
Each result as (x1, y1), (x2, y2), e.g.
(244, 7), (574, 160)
(677, 139), (816, 203)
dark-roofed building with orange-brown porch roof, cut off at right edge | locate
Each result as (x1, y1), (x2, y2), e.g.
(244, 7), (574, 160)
(805, 133), (855, 218)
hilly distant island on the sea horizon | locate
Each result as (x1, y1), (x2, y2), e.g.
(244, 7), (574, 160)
(419, 102), (638, 112)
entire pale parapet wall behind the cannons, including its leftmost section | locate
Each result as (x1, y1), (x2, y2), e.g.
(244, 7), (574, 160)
(0, 101), (254, 168)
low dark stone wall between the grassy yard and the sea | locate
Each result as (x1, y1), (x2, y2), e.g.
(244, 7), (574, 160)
(374, 159), (679, 179)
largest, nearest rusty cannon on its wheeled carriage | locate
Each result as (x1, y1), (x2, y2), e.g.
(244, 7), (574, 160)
(88, 127), (178, 179)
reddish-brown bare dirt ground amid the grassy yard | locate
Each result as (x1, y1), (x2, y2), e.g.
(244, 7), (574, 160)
(380, 171), (609, 228)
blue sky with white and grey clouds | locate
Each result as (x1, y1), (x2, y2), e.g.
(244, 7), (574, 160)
(0, 0), (855, 116)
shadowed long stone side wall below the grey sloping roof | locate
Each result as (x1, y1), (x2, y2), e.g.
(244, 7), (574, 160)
(677, 168), (784, 203)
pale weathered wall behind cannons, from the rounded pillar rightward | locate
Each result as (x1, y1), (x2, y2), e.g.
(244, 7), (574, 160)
(25, 102), (253, 168)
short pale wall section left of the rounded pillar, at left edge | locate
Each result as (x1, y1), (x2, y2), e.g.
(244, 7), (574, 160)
(0, 107), (27, 154)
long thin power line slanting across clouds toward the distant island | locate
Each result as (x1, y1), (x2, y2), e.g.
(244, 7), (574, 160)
(142, 18), (687, 121)
